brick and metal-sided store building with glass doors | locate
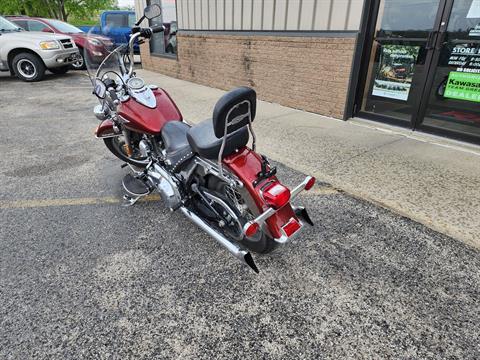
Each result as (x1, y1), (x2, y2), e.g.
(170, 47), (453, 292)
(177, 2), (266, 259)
(135, 0), (480, 142)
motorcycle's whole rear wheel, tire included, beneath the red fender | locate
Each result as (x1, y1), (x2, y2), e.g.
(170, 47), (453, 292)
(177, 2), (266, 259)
(208, 178), (277, 253)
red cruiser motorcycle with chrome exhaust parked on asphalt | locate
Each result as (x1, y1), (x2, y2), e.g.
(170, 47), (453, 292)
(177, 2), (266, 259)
(86, 5), (315, 272)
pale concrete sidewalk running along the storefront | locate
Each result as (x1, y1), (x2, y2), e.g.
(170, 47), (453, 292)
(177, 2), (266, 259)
(137, 70), (480, 248)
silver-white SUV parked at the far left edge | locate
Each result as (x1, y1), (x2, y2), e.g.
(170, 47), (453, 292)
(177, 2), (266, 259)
(0, 16), (79, 81)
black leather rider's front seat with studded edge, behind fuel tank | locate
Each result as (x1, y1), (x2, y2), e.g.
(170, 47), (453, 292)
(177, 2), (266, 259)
(162, 121), (193, 171)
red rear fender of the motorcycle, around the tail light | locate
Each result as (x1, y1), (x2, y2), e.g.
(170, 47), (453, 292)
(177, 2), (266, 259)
(223, 147), (298, 239)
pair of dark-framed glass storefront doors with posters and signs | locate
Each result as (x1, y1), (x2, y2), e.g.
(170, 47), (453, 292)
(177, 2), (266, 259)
(357, 0), (480, 140)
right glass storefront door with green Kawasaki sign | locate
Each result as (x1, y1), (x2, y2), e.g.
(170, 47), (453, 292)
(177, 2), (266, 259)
(420, 0), (480, 137)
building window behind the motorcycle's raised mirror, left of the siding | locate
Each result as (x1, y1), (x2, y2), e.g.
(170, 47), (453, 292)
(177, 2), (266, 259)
(147, 0), (178, 57)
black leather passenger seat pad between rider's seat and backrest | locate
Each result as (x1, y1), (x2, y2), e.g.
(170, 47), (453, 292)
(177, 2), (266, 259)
(187, 119), (249, 159)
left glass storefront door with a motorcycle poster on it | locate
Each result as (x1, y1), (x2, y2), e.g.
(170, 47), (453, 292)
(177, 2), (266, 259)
(361, 0), (440, 123)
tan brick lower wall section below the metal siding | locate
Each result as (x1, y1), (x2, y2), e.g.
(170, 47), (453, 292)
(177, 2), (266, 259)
(141, 32), (356, 119)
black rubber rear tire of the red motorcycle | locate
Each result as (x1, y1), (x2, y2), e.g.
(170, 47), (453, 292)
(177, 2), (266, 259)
(208, 180), (277, 254)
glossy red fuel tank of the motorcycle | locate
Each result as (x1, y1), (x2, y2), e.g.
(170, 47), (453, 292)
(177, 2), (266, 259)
(117, 89), (183, 135)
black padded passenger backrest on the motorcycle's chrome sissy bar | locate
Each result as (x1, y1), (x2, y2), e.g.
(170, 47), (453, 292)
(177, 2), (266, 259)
(213, 86), (257, 139)
